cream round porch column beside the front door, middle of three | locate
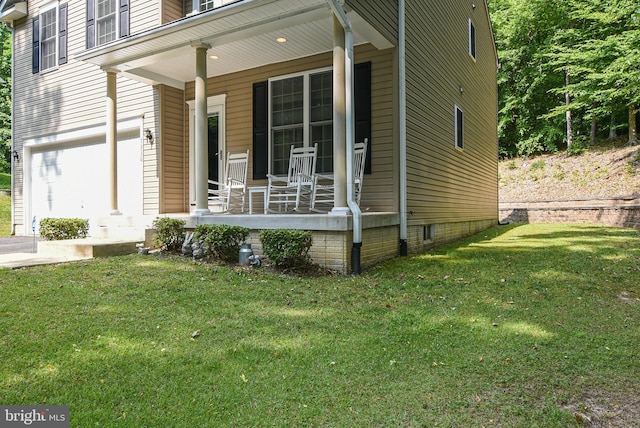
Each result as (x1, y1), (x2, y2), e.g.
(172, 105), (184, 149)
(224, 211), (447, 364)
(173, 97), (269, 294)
(193, 43), (211, 216)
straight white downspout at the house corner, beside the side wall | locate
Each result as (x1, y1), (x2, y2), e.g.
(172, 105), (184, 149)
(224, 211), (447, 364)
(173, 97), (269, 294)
(398, 0), (409, 256)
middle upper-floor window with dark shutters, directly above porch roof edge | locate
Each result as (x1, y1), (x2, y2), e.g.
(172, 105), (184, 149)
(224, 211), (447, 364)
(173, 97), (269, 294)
(87, 0), (129, 49)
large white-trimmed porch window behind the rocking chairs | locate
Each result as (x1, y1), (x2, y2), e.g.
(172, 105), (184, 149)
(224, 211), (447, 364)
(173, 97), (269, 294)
(269, 69), (333, 174)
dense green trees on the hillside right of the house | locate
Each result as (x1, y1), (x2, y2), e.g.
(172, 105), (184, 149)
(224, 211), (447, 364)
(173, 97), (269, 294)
(489, 0), (640, 155)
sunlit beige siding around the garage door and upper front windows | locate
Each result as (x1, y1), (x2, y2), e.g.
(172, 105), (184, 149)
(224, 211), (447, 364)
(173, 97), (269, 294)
(13, 0), (158, 229)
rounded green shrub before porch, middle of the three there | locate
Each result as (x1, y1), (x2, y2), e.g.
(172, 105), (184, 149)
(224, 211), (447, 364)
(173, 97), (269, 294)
(193, 224), (249, 262)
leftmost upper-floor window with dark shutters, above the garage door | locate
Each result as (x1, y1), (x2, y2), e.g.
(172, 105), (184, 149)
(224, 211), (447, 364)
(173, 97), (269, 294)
(32, 2), (67, 73)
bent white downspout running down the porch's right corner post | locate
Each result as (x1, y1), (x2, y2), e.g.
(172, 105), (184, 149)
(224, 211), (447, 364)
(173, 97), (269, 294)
(327, 0), (362, 274)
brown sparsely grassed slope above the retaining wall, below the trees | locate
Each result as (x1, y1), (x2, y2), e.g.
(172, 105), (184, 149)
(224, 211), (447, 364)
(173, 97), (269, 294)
(499, 140), (640, 202)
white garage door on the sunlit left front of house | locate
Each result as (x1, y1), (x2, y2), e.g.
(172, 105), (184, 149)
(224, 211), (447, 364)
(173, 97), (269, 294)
(31, 138), (143, 226)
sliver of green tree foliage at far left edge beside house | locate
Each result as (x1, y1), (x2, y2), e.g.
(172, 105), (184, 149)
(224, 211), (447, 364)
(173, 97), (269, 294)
(0, 24), (11, 172)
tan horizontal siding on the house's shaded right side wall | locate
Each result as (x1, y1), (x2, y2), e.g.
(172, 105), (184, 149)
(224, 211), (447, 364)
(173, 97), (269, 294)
(406, 0), (498, 224)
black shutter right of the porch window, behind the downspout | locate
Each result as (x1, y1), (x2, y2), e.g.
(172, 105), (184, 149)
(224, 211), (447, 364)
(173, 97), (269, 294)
(353, 62), (372, 174)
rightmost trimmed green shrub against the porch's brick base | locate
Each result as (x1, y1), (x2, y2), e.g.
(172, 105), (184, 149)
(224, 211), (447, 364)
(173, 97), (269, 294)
(260, 229), (313, 268)
